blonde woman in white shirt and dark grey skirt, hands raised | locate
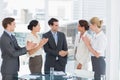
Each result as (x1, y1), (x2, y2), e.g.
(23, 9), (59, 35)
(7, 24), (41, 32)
(83, 17), (107, 80)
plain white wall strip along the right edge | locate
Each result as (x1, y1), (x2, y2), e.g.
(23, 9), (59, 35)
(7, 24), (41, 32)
(106, 0), (120, 80)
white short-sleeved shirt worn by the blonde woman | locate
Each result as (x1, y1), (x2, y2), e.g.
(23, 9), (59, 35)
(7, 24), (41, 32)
(91, 31), (107, 56)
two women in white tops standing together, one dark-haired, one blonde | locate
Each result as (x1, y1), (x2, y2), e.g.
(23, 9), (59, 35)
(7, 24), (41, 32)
(75, 17), (107, 80)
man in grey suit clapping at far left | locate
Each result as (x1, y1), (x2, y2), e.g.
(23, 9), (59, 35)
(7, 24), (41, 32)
(0, 17), (36, 80)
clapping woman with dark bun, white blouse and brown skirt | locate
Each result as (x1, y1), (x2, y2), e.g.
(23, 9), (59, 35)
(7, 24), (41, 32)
(26, 20), (48, 74)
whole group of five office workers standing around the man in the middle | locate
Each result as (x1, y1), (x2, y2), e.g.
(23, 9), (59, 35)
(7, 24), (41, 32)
(0, 17), (107, 80)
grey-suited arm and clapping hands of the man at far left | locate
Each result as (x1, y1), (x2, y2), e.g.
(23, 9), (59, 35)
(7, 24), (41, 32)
(1, 38), (36, 57)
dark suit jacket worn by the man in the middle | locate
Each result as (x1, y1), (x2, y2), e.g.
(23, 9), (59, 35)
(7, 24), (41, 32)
(43, 31), (68, 73)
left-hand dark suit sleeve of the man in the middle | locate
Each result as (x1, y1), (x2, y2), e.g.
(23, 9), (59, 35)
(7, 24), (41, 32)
(42, 34), (59, 56)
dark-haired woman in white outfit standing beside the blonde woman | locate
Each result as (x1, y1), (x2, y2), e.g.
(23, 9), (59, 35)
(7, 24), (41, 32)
(75, 20), (90, 70)
